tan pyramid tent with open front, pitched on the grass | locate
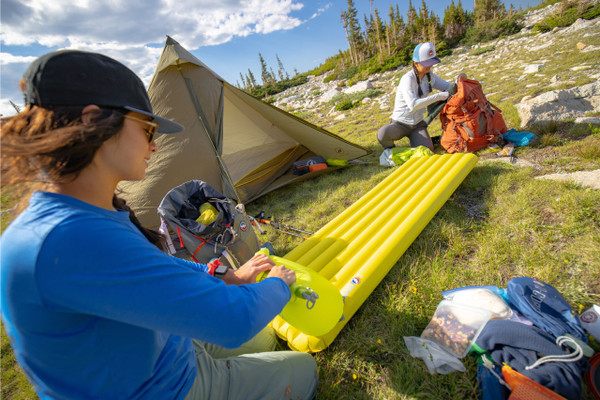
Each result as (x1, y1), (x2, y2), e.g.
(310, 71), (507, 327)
(120, 37), (369, 227)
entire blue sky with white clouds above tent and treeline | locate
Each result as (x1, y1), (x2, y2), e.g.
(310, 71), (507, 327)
(0, 0), (540, 115)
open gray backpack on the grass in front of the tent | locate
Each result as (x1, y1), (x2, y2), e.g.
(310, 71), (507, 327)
(158, 180), (260, 268)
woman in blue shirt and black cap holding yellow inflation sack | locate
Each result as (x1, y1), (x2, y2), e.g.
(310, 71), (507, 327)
(0, 50), (317, 399)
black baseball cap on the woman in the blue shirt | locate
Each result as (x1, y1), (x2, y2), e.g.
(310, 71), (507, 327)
(23, 50), (183, 133)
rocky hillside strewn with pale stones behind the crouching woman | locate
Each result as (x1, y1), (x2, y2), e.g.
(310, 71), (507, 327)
(274, 0), (600, 126)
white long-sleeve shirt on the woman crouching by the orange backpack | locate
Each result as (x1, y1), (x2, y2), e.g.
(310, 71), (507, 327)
(392, 70), (451, 125)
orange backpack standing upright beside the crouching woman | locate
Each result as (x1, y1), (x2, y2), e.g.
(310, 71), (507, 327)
(440, 77), (506, 153)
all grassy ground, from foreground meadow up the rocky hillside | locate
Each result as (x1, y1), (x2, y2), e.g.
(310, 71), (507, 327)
(1, 14), (600, 399)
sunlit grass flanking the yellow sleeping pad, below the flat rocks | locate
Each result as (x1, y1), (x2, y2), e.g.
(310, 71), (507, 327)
(248, 163), (600, 399)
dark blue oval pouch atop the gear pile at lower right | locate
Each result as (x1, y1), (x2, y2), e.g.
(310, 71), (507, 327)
(506, 276), (588, 343)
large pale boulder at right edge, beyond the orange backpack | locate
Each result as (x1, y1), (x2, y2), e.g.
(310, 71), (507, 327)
(516, 82), (600, 127)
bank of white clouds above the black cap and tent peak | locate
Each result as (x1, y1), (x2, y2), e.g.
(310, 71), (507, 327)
(0, 0), (304, 106)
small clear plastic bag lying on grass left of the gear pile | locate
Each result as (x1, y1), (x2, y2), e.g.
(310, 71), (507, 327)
(404, 336), (466, 375)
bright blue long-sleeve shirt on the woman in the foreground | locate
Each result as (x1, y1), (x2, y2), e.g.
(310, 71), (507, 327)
(0, 192), (290, 399)
